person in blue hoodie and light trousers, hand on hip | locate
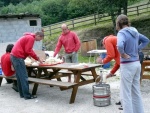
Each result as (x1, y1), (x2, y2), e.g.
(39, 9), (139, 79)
(116, 14), (150, 113)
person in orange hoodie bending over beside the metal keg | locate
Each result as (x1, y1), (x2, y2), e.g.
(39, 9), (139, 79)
(96, 35), (120, 78)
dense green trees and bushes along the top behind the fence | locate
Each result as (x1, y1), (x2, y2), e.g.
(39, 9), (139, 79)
(0, 0), (146, 25)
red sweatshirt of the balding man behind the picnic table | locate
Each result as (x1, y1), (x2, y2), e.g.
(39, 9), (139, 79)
(54, 31), (80, 56)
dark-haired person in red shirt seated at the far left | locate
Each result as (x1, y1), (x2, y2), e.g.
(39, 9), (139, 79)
(1, 44), (18, 92)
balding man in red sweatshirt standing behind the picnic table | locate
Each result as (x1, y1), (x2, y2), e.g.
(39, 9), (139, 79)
(54, 24), (81, 81)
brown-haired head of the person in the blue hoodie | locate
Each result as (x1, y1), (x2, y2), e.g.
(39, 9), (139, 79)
(116, 14), (130, 31)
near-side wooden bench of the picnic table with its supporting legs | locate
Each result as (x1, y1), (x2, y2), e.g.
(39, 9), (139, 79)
(0, 75), (77, 104)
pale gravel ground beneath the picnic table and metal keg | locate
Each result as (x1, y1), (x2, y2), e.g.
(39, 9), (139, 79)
(0, 70), (150, 113)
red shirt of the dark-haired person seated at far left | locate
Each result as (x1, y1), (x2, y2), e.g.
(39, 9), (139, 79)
(1, 53), (15, 76)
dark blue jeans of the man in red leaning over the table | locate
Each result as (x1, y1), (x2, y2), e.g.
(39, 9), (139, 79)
(11, 55), (31, 98)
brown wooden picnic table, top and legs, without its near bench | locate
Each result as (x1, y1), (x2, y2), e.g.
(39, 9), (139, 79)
(27, 63), (101, 103)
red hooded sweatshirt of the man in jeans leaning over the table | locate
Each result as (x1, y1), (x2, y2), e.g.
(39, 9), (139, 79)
(11, 33), (38, 60)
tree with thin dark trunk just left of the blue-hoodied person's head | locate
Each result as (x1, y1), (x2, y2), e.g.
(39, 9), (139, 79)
(92, 0), (137, 34)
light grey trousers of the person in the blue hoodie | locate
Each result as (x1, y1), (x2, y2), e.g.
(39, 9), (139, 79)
(120, 61), (144, 113)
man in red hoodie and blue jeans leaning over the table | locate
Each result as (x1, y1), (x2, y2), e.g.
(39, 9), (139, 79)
(11, 32), (44, 100)
